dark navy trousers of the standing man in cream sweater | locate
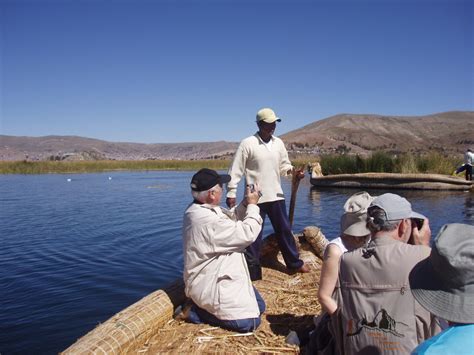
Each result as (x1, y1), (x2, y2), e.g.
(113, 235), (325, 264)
(246, 200), (303, 280)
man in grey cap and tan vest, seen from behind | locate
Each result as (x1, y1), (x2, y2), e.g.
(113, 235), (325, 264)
(331, 193), (441, 354)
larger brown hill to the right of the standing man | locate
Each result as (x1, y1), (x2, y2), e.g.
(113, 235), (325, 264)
(281, 111), (474, 154)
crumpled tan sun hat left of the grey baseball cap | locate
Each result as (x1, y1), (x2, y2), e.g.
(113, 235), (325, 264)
(341, 191), (374, 237)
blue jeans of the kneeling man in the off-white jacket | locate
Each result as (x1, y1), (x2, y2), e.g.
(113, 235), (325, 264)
(187, 287), (265, 333)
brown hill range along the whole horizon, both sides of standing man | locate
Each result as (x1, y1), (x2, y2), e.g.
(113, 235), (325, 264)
(0, 111), (474, 160)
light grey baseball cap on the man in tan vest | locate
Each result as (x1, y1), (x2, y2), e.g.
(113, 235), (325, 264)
(369, 193), (426, 221)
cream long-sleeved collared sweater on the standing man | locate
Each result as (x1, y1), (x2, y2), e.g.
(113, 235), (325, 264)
(227, 133), (293, 203)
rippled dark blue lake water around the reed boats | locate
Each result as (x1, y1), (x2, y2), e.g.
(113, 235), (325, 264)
(0, 171), (474, 354)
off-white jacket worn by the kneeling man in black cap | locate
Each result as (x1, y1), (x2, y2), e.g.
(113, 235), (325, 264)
(183, 203), (262, 320)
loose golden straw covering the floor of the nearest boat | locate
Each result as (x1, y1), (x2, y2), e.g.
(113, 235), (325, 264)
(137, 227), (327, 354)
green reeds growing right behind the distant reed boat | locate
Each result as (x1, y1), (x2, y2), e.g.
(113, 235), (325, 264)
(312, 152), (462, 175)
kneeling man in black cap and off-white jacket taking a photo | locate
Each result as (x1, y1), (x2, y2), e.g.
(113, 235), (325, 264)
(183, 168), (265, 332)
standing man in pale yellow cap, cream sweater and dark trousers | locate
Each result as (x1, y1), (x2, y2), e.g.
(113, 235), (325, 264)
(226, 108), (309, 280)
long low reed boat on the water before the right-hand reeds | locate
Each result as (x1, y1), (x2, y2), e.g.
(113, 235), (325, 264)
(310, 173), (473, 191)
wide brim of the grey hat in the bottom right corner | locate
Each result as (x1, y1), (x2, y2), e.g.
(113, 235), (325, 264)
(409, 258), (474, 323)
